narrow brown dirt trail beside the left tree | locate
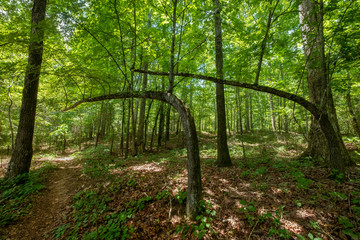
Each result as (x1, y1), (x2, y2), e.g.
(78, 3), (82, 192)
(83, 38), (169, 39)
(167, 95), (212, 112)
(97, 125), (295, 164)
(5, 157), (84, 239)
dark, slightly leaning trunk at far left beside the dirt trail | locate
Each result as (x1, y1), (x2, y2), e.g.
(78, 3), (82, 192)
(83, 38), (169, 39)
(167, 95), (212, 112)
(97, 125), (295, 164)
(5, 0), (47, 178)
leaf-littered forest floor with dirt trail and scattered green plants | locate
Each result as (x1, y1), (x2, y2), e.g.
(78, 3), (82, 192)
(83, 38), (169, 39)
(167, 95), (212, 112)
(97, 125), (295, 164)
(0, 132), (360, 240)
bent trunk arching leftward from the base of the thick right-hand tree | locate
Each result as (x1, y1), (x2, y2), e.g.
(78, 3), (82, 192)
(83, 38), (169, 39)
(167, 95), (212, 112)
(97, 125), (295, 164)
(134, 69), (347, 173)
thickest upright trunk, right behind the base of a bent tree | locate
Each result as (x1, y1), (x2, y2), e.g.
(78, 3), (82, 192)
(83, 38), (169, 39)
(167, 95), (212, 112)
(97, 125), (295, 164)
(299, 0), (352, 172)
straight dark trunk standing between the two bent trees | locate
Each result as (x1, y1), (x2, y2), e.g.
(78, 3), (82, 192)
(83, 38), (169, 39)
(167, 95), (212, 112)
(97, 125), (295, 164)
(213, 0), (232, 167)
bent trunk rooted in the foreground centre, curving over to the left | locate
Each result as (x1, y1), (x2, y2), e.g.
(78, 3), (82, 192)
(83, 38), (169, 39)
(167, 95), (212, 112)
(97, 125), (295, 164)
(63, 91), (202, 219)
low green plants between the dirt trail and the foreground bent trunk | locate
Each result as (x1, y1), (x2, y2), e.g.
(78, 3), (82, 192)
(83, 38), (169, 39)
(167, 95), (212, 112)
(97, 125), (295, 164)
(52, 180), (191, 240)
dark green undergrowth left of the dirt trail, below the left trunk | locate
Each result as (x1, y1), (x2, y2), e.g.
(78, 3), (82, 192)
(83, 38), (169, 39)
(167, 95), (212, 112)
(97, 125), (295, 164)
(0, 162), (56, 231)
